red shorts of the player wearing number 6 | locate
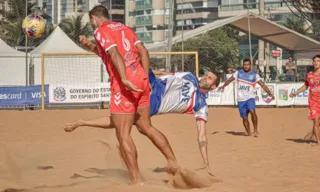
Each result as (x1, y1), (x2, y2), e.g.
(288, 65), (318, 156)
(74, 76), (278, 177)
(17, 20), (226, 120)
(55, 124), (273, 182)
(110, 79), (150, 114)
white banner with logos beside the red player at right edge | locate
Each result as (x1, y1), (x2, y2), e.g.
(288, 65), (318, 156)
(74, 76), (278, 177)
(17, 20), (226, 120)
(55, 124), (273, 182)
(277, 83), (309, 106)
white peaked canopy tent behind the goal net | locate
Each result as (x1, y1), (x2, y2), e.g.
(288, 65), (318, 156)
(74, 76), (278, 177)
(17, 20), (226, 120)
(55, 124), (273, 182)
(30, 26), (108, 84)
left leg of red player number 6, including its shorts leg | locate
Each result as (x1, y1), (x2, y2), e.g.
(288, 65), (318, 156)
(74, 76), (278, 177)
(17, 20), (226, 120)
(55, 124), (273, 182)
(110, 91), (142, 184)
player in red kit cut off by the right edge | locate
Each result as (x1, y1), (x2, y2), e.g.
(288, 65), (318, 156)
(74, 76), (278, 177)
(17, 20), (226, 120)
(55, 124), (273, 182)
(290, 55), (320, 145)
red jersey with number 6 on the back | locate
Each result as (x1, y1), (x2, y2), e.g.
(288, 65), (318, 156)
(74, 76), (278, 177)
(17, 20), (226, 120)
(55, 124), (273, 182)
(94, 22), (147, 92)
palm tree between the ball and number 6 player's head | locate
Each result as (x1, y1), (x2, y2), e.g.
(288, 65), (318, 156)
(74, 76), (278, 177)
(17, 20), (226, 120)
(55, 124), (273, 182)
(59, 14), (93, 45)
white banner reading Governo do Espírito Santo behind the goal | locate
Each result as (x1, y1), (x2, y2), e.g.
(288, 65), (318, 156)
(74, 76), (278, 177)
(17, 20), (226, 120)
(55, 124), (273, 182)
(49, 83), (110, 103)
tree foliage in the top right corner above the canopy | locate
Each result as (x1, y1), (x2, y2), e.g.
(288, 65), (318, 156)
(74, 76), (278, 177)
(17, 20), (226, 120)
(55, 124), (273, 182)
(283, 0), (320, 40)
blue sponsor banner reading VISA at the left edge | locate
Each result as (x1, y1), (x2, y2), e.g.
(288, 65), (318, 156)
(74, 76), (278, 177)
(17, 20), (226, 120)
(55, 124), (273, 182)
(0, 85), (49, 106)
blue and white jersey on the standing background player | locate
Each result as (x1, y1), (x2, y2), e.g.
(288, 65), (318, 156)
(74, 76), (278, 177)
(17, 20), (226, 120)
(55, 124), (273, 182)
(233, 69), (261, 101)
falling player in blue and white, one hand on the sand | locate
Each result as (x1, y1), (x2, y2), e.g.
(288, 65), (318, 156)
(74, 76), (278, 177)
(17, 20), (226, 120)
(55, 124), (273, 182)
(64, 70), (217, 175)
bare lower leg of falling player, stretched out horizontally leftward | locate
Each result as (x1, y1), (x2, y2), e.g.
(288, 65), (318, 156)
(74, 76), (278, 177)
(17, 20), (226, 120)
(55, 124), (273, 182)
(64, 117), (115, 132)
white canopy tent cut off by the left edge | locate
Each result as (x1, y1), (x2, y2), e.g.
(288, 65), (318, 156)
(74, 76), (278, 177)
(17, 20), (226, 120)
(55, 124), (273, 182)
(0, 39), (26, 86)
